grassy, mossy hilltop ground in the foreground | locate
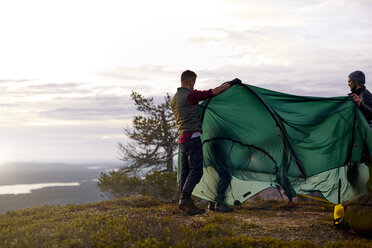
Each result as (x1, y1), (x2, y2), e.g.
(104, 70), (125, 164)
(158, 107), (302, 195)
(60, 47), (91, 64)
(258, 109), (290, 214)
(0, 197), (372, 247)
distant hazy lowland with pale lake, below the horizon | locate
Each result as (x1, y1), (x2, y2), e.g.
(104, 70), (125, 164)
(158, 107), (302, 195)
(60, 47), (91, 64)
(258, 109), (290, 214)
(0, 163), (120, 213)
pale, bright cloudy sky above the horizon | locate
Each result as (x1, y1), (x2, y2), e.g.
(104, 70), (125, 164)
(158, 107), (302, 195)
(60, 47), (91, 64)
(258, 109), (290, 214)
(0, 0), (372, 164)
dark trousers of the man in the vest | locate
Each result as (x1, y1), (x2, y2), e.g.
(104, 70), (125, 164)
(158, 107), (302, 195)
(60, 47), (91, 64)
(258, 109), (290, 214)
(180, 137), (203, 197)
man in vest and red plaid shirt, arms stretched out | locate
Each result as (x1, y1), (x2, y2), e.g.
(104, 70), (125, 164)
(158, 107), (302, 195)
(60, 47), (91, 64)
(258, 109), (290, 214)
(170, 70), (241, 215)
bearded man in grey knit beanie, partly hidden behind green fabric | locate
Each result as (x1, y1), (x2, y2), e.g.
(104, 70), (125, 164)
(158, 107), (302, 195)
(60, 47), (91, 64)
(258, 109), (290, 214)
(348, 71), (372, 192)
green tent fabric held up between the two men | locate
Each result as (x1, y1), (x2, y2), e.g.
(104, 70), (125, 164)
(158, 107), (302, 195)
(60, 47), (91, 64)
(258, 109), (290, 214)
(178, 84), (372, 205)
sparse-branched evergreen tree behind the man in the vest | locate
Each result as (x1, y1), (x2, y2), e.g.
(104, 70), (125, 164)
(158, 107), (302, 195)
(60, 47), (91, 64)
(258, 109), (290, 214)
(118, 91), (177, 173)
